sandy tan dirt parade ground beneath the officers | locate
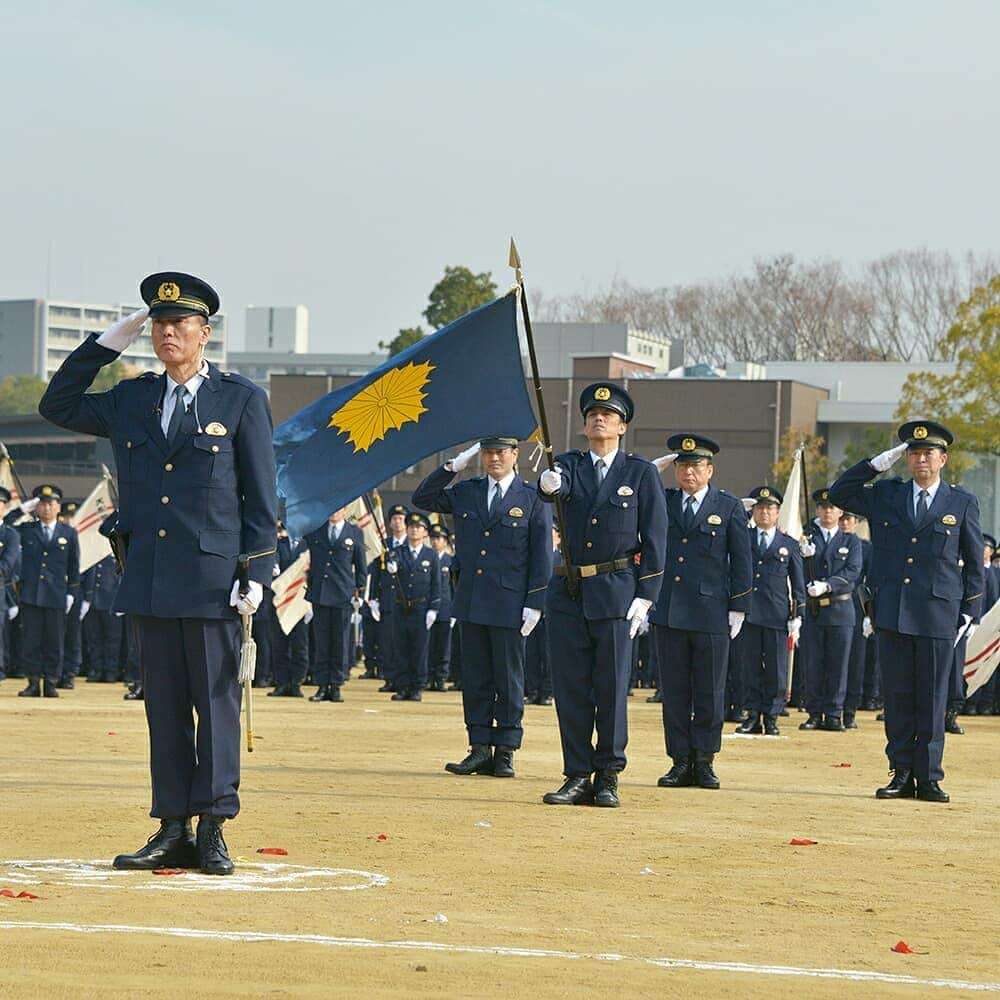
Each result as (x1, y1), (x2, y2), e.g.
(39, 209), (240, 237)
(0, 680), (1000, 998)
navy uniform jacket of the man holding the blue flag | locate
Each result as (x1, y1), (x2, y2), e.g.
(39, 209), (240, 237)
(536, 449), (667, 621)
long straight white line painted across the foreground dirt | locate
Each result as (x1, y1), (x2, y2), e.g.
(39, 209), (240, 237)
(0, 920), (1000, 993)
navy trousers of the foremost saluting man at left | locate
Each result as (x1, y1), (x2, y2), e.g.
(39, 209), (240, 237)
(135, 615), (242, 819)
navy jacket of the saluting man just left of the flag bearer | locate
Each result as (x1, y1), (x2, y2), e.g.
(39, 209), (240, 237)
(413, 466), (552, 628)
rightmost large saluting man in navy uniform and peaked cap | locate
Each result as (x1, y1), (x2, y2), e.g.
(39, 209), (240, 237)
(830, 420), (983, 802)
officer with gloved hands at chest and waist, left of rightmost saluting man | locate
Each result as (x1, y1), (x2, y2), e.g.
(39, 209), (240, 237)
(799, 489), (862, 733)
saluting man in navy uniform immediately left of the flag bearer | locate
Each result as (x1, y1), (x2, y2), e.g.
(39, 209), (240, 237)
(413, 436), (552, 778)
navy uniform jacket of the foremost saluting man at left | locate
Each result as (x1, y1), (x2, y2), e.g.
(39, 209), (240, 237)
(38, 337), (277, 618)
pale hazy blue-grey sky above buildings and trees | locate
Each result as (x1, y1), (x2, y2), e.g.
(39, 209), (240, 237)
(0, 0), (1000, 351)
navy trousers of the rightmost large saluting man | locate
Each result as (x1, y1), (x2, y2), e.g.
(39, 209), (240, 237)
(876, 629), (954, 781)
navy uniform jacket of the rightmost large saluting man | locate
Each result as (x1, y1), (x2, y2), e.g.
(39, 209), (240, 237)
(830, 461), (984, 639)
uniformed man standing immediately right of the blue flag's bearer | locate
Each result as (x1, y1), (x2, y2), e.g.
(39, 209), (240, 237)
(650, 433), (753, 789)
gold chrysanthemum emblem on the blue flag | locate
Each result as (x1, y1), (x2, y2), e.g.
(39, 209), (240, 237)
(327, 361), (434, 452)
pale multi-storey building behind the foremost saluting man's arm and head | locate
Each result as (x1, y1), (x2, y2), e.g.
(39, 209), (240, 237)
(0, 299), (226, 382)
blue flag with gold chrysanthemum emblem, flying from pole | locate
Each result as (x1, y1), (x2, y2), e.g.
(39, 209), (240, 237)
(274, 292), (536, 536)
